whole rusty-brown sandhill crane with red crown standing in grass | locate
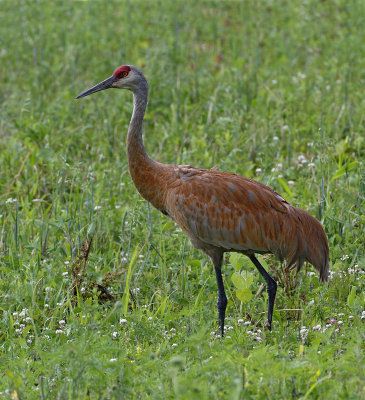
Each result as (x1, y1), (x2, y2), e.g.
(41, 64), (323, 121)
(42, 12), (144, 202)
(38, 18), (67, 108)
(77, 65), (329, 336)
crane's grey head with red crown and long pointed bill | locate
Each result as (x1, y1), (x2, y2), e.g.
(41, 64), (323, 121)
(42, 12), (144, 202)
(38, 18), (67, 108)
(76, 65), (148, 99)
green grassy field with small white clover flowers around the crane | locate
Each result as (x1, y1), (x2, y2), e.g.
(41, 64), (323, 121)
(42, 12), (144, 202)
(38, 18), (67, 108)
(0, 0), (365, 400)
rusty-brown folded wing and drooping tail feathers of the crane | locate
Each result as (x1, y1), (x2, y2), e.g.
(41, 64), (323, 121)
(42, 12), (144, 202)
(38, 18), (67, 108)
(167, 166), (329, 281)
